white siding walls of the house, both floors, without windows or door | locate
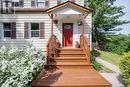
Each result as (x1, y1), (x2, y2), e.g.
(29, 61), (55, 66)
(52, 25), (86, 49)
(0, 0), (92, 50)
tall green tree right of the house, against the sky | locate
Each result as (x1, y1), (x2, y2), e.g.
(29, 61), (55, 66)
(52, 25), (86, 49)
(85, 0), (129, 48)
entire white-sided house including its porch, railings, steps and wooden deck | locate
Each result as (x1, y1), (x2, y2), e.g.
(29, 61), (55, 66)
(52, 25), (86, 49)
(0, 0), (111, 87)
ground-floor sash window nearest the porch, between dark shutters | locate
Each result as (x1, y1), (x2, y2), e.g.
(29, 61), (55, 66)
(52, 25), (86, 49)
(31, 23), (39, 37)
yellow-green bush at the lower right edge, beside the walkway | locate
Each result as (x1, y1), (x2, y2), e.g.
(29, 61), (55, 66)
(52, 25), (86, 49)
(120, 51), (130, 87)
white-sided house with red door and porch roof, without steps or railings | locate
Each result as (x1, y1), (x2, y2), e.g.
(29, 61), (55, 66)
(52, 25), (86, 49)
(0, 0), (92, 51)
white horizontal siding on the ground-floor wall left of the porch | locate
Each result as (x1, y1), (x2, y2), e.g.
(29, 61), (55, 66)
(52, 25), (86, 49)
(0, 14), (57, 50)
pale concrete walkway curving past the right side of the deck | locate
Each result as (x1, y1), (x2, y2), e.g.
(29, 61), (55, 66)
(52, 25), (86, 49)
(96, 57), (126, 87)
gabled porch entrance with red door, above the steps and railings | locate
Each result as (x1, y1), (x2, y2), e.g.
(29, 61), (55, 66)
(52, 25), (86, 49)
(47, 1), (91, 47)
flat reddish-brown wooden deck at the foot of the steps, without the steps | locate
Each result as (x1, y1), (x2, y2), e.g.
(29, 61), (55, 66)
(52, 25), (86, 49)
(31, 69), (111, 87)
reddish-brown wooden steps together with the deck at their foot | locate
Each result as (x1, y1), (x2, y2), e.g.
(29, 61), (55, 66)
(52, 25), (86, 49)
(31, 48), (111, 87)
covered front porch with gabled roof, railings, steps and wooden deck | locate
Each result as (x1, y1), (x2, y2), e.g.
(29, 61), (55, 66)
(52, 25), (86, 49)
(31, 1), (111, 87)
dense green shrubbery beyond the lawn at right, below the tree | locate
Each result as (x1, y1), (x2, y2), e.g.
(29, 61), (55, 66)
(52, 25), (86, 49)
(105, 34), (130, 54)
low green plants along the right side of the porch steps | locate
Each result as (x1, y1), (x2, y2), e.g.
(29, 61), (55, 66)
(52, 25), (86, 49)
(91, 51), (102, 70)
